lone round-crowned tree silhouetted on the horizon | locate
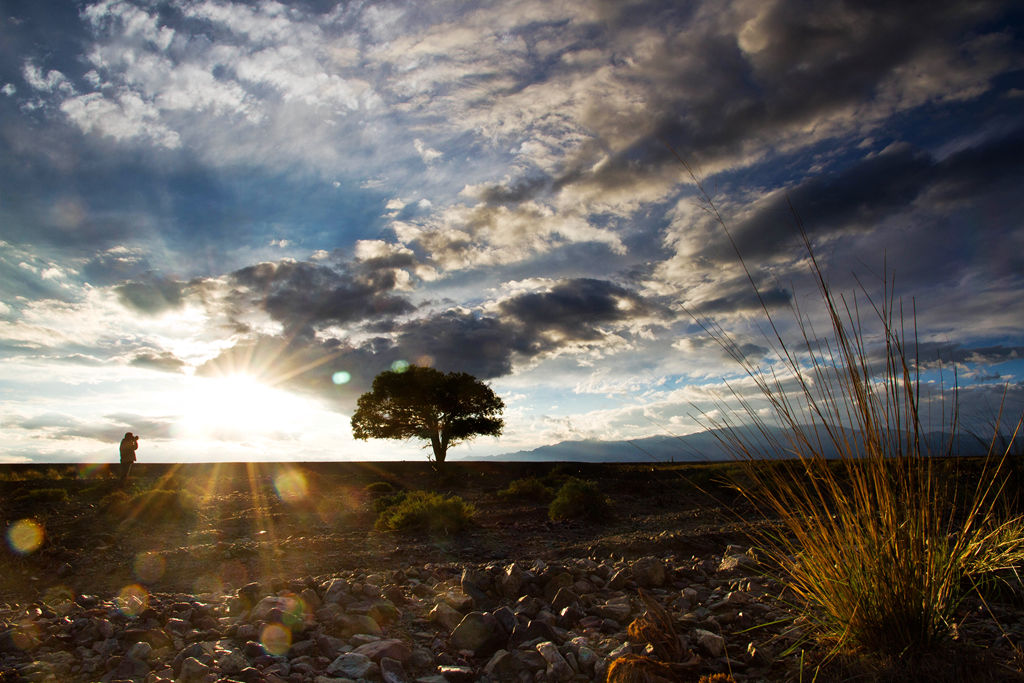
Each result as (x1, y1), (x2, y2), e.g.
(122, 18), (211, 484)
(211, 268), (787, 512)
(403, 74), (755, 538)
(352, 366), (505, 465)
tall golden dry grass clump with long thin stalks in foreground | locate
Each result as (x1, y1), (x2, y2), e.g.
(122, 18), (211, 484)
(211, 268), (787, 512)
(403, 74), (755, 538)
(679, 153), (1024, 655)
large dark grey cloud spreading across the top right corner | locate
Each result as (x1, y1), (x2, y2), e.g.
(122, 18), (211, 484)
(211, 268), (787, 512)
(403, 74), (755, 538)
(483, 0), (1020, 208)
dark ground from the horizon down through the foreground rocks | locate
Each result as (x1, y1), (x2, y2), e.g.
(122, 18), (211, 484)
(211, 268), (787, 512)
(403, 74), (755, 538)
(0, 463), (1024, 683)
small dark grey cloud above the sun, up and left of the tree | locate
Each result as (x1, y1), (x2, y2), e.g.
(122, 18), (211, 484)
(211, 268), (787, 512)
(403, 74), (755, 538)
(229, 259), (415, 336)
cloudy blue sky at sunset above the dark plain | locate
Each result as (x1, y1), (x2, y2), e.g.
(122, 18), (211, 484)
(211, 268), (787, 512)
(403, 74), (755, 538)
(0, 0), (1024, 462)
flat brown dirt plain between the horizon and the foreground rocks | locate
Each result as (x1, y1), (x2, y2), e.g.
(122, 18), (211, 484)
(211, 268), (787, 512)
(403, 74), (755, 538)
(0, 462), (744, 603)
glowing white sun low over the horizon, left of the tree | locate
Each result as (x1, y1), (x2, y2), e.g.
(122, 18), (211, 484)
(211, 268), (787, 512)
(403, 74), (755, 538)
(182, 374), (309, 441)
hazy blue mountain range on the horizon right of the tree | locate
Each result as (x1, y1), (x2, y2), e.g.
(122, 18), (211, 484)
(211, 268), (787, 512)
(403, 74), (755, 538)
(487, 427), (982, 463)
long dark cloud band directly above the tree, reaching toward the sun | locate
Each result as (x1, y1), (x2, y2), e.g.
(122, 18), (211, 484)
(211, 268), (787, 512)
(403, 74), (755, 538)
(197, 273), (664, 410)
